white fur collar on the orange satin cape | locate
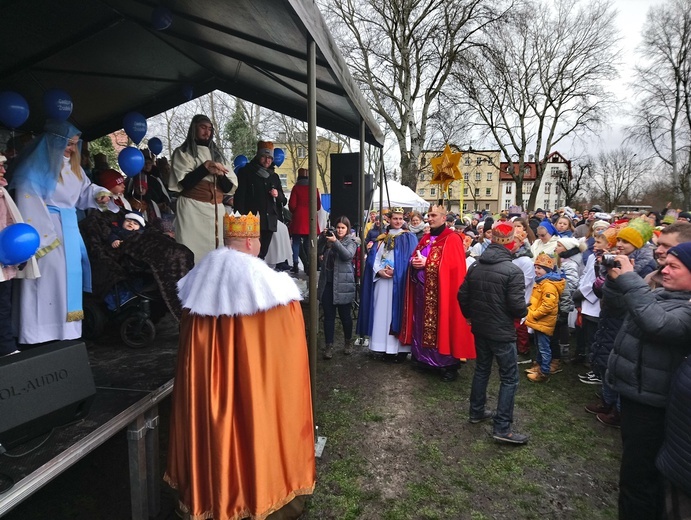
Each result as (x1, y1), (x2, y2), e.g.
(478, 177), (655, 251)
(178, 247), (302, 316)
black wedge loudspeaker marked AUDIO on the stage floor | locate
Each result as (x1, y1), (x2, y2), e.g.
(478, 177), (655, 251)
(0, 341), (96, 448)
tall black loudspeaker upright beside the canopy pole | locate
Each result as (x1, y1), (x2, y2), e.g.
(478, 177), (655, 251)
(330, 152), (374, 229)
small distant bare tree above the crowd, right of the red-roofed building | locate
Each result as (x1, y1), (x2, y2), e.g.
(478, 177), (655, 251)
(588, 146), (650, 211)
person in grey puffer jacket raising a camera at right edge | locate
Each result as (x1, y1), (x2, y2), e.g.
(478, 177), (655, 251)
(605, 242), (691, 520)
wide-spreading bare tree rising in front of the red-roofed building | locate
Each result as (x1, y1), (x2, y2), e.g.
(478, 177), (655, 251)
(455, 0), (618, 208)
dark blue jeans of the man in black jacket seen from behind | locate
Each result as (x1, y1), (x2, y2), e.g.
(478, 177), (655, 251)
(470, 336), (518, 433)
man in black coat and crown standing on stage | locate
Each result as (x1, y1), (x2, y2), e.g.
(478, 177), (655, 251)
(233, 141), (286, 260)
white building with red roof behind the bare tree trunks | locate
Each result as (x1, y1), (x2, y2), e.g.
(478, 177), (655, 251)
(499, 152), (571, 211)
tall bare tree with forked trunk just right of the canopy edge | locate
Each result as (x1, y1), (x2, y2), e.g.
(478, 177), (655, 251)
(321, 0), (505, 190)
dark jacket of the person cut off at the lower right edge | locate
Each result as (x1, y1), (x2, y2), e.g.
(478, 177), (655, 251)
(657, 358), (691, 496)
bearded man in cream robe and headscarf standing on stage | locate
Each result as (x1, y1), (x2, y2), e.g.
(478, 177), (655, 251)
(168, 114), (238, 264)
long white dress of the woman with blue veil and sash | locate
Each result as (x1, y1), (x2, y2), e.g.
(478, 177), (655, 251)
(15, 157), (118, 344)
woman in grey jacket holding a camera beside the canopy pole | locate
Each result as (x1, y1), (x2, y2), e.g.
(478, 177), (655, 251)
(317, 217), (358, 359)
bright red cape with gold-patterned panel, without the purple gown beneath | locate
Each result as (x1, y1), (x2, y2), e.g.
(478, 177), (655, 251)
(399, 228), (475, 359)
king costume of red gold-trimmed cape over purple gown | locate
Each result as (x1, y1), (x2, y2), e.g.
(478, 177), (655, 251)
(399, 226), (475, 369)
